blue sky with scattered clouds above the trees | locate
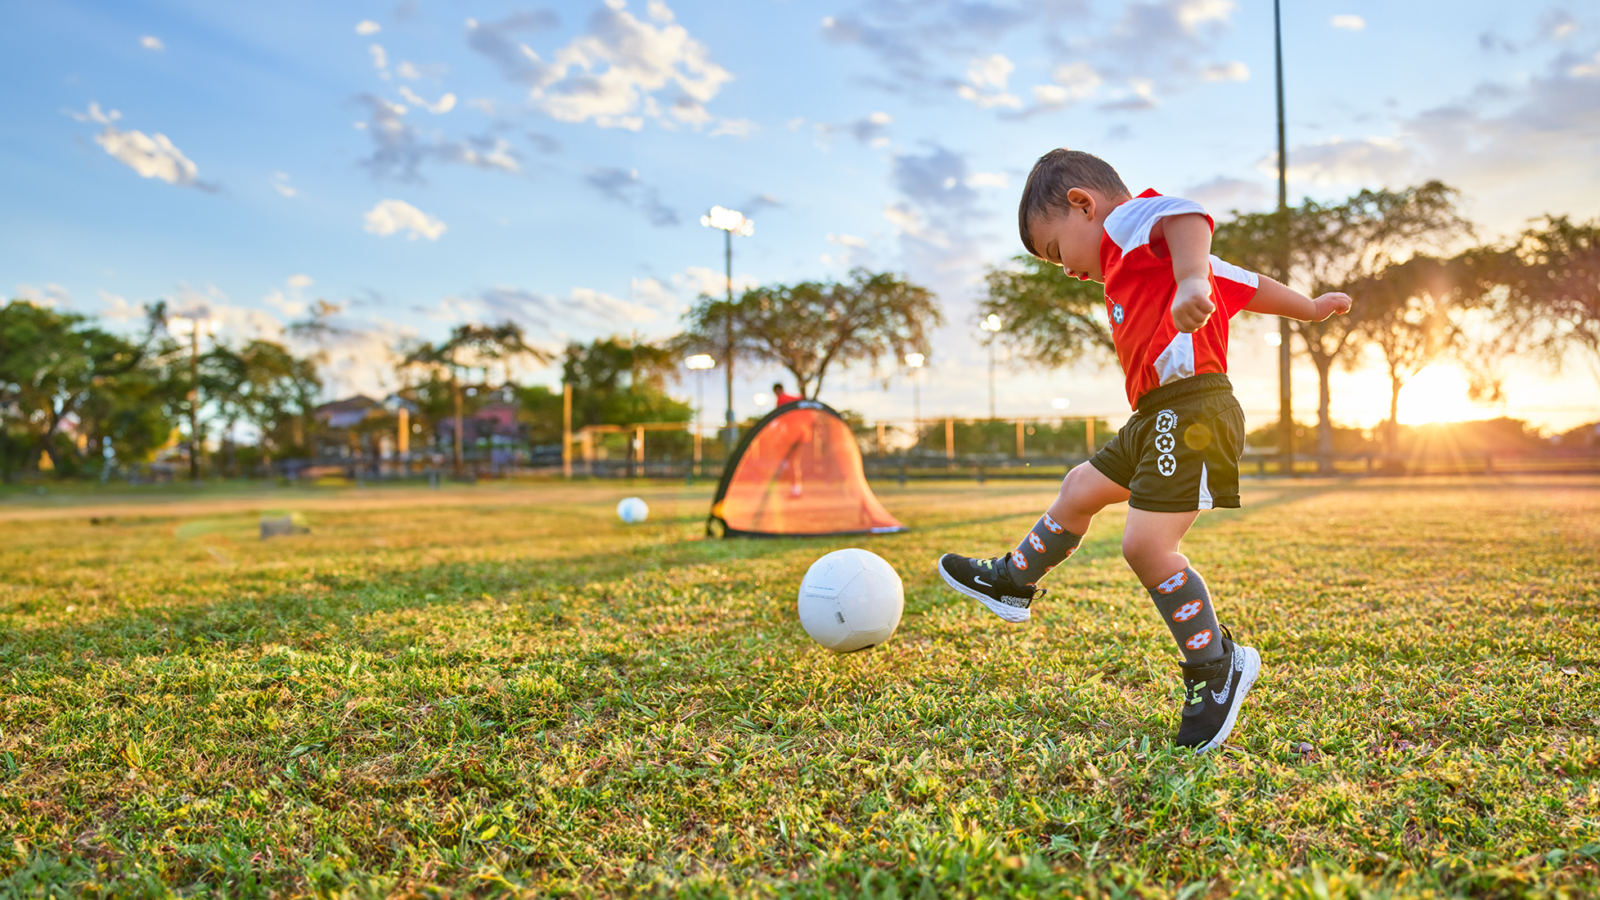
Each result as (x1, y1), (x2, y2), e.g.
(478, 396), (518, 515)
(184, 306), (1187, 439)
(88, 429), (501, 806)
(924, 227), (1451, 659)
(0, 0), (1600, 426)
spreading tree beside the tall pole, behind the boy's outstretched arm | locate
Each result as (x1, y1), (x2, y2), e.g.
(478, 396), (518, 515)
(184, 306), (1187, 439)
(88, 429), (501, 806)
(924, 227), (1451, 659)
(1211, 181), (1472, 471)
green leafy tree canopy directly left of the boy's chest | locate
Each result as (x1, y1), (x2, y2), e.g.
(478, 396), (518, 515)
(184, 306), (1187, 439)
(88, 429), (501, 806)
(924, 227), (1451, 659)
(978, 256), (1117, 368)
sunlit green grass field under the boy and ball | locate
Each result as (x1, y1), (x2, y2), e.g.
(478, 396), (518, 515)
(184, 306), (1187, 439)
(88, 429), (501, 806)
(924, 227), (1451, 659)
(0, 479), (1600, 898)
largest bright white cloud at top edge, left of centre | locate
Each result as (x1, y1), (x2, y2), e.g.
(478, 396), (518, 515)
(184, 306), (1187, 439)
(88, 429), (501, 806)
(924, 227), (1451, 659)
(467, 0), (733, 133)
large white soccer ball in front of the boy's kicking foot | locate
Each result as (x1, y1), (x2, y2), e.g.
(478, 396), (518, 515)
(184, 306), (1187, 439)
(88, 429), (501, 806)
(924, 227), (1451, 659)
(800, 548), (906, 653)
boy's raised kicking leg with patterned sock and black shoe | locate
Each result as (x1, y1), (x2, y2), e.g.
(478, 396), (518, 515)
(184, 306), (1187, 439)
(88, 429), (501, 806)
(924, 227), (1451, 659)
(938, 463), (1128, 621)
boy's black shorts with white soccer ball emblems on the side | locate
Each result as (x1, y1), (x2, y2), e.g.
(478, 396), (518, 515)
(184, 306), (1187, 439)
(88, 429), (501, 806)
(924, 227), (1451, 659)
(1090, 373), (1245, 512)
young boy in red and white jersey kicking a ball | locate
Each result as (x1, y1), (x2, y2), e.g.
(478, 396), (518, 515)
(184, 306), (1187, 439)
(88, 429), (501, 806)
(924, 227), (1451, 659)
(939, 149), (1350, 753)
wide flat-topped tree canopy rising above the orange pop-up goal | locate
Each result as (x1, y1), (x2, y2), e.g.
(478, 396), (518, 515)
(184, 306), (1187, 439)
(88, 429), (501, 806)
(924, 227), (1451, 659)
(675, 269), (944, 399)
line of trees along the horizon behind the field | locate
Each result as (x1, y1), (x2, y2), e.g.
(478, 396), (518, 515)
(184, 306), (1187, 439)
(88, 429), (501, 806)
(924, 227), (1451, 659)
(0, 181), (1600, 480)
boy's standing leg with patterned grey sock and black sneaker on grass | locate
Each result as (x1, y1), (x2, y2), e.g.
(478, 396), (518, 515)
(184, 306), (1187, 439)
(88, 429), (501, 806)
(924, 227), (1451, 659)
(1122, 509), (1261, 753)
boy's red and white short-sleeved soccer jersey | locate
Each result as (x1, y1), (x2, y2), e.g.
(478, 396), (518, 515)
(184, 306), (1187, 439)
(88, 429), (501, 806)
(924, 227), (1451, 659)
(1101, 191), (1261, 410)
